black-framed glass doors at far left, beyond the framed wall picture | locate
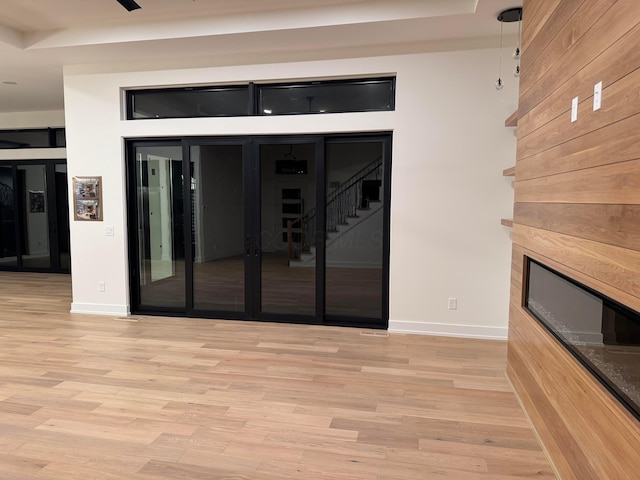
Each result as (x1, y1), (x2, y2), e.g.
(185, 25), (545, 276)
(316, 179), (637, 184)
(0, 160), (71, 273)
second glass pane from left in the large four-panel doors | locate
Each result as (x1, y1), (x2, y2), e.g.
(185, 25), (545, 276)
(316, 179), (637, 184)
(190, 145), (245, 312)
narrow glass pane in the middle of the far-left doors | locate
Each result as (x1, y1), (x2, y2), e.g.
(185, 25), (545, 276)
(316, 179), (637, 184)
(17, 165), (51, 268)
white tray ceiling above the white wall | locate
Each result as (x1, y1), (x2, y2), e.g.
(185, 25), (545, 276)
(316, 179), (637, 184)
(0, 0), (522, 112)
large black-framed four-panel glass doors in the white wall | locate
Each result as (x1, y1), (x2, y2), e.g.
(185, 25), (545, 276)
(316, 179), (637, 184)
(128, 134), (390, 328)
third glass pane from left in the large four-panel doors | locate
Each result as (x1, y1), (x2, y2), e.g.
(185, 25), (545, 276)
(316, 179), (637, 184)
(259, 143), (316, 315)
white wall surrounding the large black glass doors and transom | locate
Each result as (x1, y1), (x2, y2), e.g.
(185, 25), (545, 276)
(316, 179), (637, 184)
(65, 49), (517, 338)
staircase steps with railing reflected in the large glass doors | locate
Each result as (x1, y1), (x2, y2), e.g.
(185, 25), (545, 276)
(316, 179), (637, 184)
(287, 157), (382, 267)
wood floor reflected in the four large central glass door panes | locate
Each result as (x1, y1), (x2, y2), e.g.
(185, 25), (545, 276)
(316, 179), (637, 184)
(141, 254), (382, 318)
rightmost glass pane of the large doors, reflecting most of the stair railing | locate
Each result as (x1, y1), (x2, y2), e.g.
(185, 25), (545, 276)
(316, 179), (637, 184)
(325, 141), (385, 319)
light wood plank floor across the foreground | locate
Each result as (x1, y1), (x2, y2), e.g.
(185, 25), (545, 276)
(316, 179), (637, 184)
(0, 273), (555, 480)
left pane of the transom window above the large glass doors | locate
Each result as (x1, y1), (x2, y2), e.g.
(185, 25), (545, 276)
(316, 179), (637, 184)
(127, 85), (250, 120)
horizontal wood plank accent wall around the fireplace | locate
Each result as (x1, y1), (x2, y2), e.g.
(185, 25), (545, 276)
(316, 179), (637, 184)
(507, 0), (640, 480)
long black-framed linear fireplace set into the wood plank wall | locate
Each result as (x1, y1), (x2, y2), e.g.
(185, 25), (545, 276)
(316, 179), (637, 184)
(525, 258), (640, 420)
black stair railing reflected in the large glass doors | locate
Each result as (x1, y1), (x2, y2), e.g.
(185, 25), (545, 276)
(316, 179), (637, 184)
(287, 156), (382, 260)
